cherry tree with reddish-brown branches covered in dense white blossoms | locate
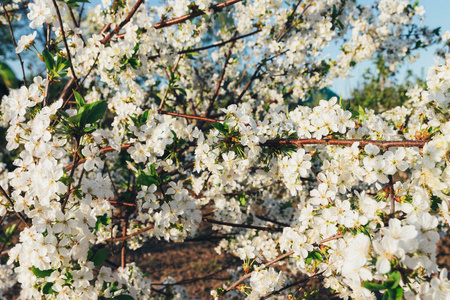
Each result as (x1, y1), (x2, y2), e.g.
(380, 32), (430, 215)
(0, 0), (450, 299)
